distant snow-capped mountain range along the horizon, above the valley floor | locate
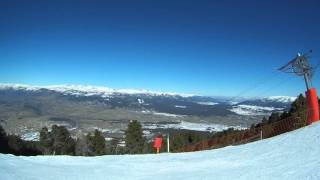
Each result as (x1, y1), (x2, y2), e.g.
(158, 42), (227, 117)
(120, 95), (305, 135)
(0, 84), (295, 116)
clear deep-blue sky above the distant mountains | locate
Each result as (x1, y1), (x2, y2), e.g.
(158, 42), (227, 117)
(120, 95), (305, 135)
(0, 0), (320, 96)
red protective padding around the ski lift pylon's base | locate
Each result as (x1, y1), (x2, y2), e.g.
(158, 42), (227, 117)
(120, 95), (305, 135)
(306, 88), (319, 124)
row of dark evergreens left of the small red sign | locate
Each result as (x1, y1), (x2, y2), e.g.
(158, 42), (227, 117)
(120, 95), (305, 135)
(0, 120), (152, 156)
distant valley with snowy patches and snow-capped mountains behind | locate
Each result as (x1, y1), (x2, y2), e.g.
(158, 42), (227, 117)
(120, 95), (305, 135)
(0, 84), (294, 137)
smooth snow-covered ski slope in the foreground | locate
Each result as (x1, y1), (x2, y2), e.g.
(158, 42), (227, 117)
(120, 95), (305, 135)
(0, 123), (320, 180)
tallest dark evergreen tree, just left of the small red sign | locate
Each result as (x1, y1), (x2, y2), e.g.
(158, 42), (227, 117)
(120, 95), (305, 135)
(125, 120), (145, 154)
